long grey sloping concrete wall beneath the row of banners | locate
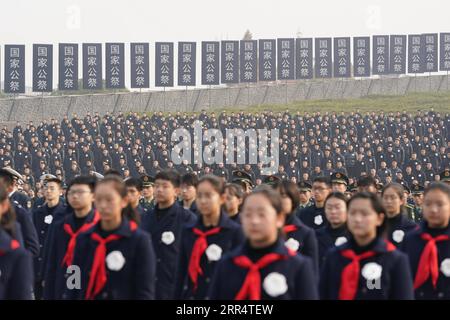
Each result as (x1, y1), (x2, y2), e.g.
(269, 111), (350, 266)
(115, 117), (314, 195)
(0, 75), (449, 124)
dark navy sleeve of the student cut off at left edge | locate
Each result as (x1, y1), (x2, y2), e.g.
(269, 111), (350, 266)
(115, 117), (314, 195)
(8, 250), (33, 300)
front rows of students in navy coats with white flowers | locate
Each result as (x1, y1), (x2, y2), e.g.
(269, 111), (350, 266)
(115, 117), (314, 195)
(0, 162), (450, 300)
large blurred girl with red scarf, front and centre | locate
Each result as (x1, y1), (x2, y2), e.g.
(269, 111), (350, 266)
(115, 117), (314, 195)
(208, 186), (318, 300)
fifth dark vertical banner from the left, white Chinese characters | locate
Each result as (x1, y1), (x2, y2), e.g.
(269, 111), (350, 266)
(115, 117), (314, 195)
(105, 43), (125, 89)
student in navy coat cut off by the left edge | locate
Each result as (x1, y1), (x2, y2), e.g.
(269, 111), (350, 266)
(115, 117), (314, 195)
(0, 186), (33, 301)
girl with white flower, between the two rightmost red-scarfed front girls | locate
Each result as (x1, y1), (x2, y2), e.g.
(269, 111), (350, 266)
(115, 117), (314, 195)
(381, 182), (418, 246)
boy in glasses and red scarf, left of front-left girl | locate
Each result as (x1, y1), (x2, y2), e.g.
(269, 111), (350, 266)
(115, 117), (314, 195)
(44, 176), (100, 300)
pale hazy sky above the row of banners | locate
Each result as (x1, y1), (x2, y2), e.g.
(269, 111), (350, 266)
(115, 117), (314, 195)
(0, 0), (450, 90)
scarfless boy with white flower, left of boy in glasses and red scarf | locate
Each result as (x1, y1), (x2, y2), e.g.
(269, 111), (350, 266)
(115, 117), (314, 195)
(32, 178), (67, 300)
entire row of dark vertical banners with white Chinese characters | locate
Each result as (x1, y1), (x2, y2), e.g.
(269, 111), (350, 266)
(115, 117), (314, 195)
(4, 33), (450, 93)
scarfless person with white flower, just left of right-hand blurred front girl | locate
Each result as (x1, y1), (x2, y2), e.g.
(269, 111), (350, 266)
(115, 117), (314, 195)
(316, 192), (350, 265)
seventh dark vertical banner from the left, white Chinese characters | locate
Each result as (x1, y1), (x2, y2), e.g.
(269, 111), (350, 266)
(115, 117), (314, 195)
(155, 42), (173, 87)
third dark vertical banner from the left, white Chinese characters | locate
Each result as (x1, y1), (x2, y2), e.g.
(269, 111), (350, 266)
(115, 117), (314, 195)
(58, 43), (78, 90)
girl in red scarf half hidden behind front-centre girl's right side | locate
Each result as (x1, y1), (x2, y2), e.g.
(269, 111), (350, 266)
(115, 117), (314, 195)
(272, 180), (319, 273)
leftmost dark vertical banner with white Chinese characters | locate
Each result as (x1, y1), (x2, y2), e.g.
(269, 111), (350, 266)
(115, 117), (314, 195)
(4, 45), (25, 93)
